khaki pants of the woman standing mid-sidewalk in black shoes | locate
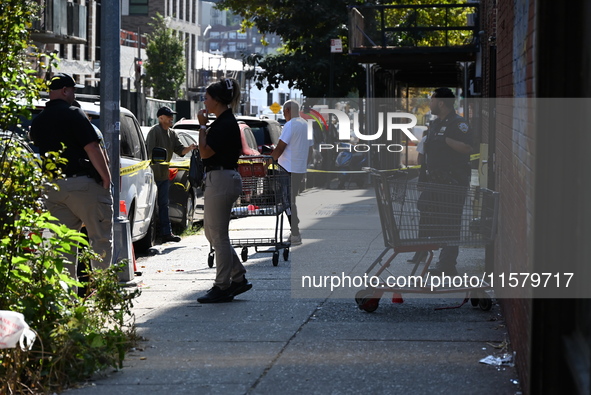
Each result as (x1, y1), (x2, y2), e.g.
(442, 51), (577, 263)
(203, 170), (246, 289)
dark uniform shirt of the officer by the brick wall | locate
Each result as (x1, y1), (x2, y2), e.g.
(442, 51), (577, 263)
(425, 112), (472, 171)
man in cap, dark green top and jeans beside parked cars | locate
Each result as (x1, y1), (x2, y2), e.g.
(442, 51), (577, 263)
(146, 106), (197, 242)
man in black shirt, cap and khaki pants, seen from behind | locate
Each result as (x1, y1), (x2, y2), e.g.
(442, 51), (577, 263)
(30, 73), (113, 288)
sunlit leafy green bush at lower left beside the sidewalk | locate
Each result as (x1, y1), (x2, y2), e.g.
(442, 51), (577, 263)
(0, 138), (139, 393)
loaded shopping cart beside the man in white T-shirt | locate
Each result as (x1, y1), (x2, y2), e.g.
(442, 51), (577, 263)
(207, 155), (291, 267)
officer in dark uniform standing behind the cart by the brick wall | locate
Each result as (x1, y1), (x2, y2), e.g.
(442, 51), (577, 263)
(421, 88), (472, 276)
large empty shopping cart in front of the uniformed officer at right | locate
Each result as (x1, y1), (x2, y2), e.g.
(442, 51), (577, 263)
(355, 169), (499, 312)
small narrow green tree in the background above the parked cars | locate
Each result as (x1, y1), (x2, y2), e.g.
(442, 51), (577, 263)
(145, 13), (185, 100)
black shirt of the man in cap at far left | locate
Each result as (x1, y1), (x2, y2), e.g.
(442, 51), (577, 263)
(30, 99), (99, 176)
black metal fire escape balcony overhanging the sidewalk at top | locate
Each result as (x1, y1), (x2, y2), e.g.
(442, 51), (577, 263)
(349, 3), (480, 92)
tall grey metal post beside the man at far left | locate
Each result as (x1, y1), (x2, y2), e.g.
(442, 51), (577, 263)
(100, 0), (121, 262)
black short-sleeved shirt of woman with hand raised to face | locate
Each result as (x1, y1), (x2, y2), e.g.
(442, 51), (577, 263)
(203, 108), (242, 169)
